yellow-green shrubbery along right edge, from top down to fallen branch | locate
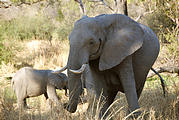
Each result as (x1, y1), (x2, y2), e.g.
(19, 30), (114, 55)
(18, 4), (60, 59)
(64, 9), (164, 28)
(146, 0), (179, 66)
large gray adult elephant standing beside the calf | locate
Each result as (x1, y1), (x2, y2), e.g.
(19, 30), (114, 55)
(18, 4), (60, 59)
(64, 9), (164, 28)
(67, 14), (160, 116)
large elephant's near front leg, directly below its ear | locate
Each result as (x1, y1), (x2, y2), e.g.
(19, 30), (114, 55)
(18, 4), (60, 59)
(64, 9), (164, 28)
(116, 56), (139, 115)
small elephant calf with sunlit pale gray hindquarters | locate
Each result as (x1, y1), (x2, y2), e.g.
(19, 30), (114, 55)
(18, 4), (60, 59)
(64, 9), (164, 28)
(12, 67), (68, 108)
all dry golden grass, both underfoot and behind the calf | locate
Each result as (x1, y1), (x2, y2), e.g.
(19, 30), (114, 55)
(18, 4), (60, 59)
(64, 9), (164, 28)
(0, 40), (179, 120)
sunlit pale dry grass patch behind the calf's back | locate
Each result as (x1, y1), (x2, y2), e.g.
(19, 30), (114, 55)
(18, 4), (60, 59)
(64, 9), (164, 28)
(13, 40), (68, 69)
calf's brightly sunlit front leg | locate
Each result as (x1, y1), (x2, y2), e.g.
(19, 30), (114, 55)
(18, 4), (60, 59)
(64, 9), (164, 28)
(47, 84), (59, 104)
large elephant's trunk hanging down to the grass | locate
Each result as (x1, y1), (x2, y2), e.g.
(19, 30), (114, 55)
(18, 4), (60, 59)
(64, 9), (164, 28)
(67, 50), (87, 113)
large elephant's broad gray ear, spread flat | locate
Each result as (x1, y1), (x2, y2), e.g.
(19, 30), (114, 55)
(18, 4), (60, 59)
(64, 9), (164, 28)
(99, 15), (144, 71)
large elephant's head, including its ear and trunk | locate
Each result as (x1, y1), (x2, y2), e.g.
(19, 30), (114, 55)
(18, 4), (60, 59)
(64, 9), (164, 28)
(67, 14), (144, 112)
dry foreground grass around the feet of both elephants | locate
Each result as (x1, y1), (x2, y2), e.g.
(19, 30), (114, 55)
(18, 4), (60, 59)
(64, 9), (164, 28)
(0, 72), (179, 120)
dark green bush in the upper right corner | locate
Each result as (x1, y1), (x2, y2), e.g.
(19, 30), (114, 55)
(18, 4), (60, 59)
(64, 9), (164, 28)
(146, 0), (179, 42)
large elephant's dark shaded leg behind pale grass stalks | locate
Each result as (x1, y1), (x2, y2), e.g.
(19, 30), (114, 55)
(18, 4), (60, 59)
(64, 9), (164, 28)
(87, 68), (118, 119)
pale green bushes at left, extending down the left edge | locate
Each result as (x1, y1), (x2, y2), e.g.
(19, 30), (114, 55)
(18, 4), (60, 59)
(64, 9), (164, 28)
(0, 16), (55, 64)
